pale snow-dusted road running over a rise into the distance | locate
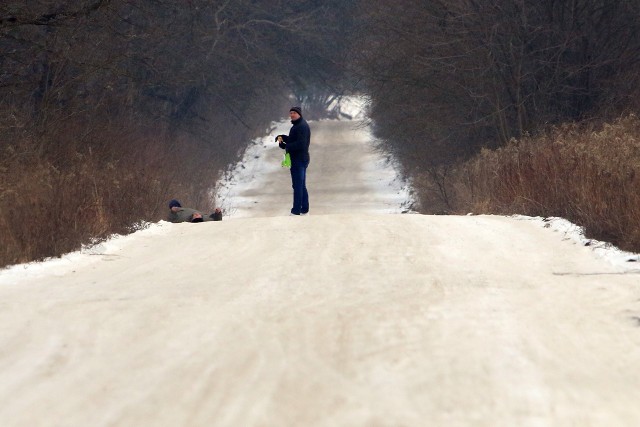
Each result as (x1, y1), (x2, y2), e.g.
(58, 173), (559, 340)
(0, 118), (640, 427)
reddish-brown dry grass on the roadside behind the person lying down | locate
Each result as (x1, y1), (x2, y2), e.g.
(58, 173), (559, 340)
(0, 113), (220, 267)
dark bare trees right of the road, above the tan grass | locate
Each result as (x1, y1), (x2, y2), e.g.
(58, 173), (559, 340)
(354, 0), (640, 176)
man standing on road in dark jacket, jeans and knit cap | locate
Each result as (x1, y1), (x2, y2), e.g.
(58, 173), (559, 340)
(276, 107), (311, 215)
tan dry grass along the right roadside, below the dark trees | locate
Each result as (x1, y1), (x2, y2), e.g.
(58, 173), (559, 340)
(449, 115), (640, 251)
